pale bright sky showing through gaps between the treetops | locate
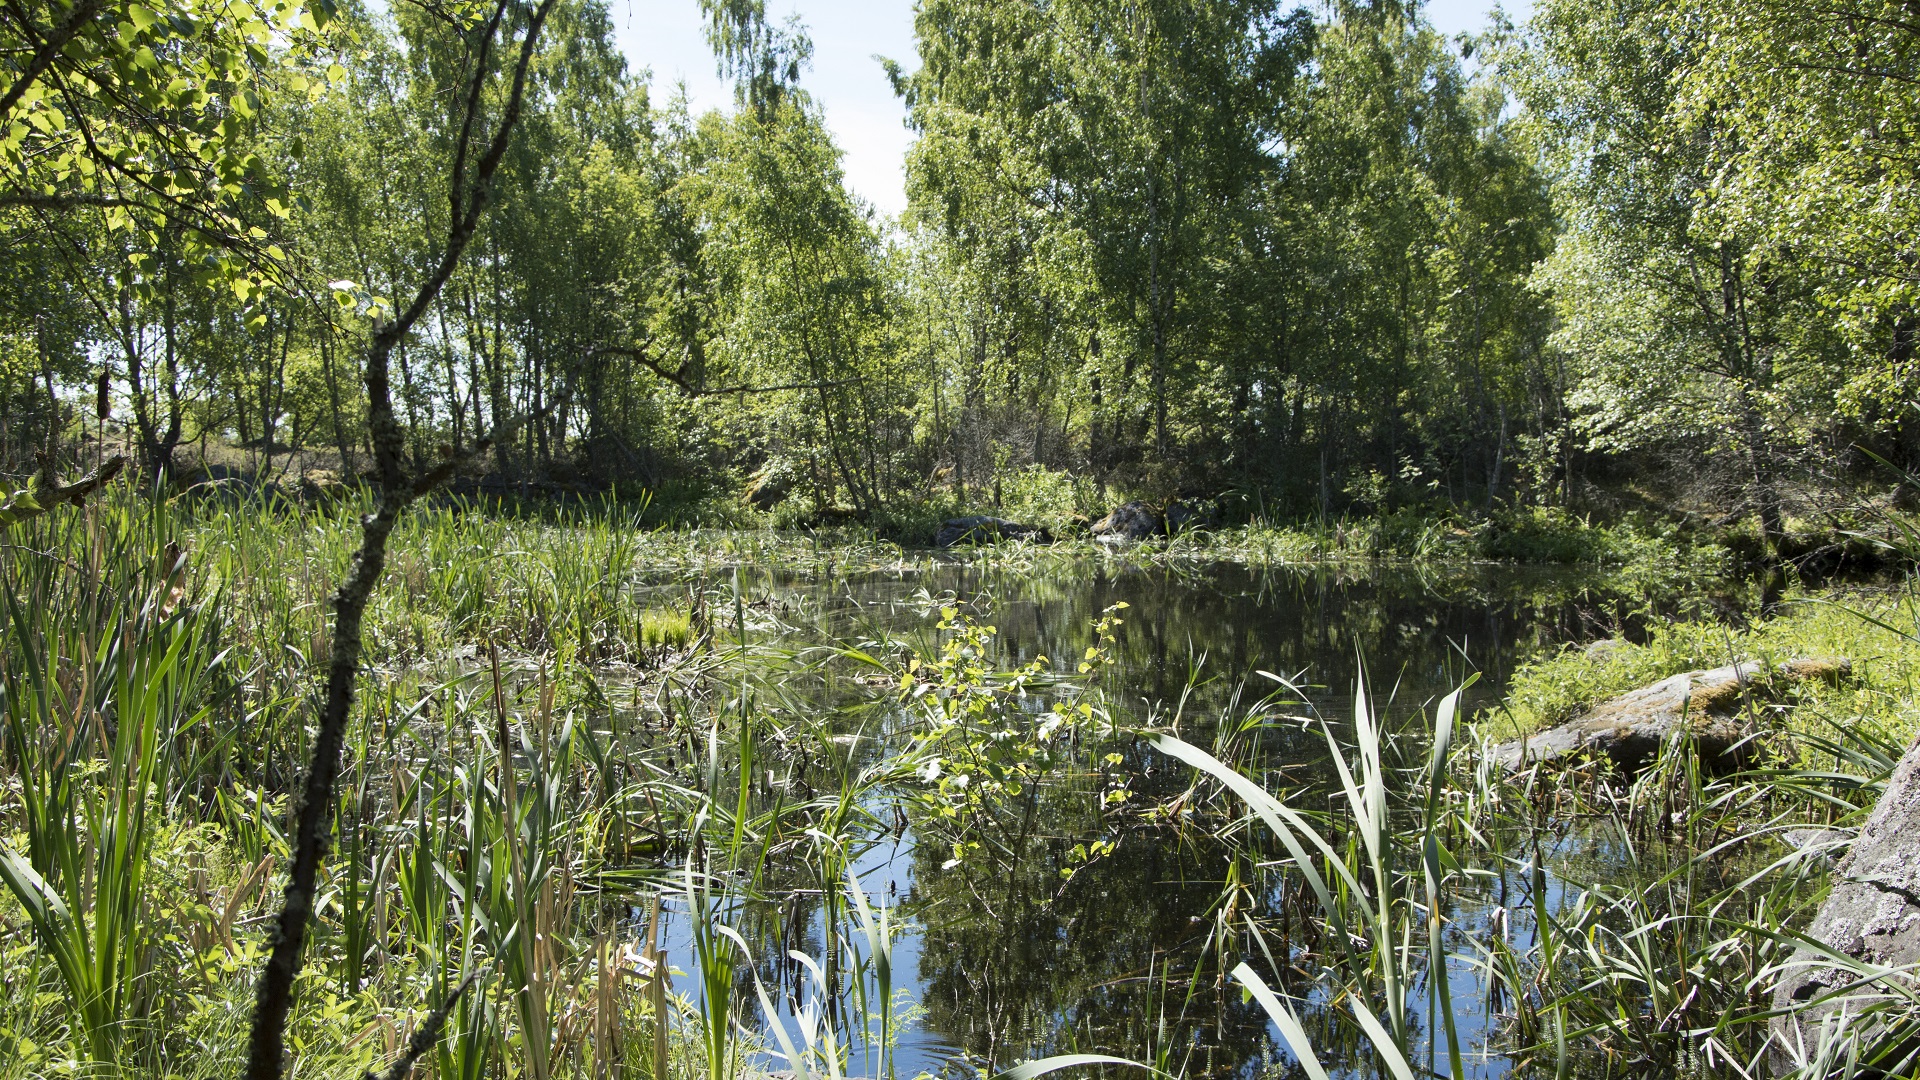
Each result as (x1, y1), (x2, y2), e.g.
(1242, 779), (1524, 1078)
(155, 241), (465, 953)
(609, 0), (1530, 215)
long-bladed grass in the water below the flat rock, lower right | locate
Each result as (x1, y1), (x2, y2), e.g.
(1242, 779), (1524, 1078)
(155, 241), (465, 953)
(1146, 645), (1920, 1080)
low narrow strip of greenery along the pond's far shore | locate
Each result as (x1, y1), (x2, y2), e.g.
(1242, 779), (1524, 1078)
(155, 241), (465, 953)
(112, 461), (1910, 580)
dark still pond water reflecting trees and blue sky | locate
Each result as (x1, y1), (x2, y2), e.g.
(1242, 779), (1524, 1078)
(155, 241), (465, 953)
(637, 561), (1689, 1076)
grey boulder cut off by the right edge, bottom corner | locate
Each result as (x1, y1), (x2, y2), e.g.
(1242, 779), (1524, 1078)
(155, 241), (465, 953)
(1772, 740), (1920, 1074)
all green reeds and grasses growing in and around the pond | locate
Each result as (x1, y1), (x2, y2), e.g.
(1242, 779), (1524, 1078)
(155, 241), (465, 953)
(0, 488), (1920, 1078)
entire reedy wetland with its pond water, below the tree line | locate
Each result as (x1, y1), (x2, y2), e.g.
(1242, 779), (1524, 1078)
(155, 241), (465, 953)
(0, 496), (1920, 1076)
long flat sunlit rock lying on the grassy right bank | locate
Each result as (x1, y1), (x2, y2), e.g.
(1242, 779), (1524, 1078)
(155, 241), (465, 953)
(1494, 659), (1853, 776)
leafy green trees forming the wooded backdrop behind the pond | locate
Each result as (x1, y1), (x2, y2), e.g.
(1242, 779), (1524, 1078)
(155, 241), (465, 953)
(0, 0), (1920, 538)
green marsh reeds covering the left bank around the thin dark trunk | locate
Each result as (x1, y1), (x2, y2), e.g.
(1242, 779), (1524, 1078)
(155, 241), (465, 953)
(0, 500), (944, 1080)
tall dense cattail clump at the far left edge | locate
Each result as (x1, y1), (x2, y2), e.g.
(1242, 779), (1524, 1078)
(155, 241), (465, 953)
(0, 499), (219, 1065)
